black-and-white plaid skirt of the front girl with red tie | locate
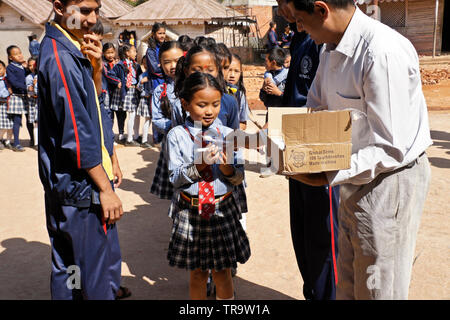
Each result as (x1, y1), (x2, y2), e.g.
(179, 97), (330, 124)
(167, 193), (251, 271)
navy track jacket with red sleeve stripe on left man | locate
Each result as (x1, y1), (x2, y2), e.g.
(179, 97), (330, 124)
(38, 24), (113, 207)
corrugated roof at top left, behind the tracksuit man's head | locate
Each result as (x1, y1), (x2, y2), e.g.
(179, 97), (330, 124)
(2, 0), (133, 24)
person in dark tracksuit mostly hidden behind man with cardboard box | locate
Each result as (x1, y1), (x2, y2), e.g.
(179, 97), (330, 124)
(278, 0), (339, 300)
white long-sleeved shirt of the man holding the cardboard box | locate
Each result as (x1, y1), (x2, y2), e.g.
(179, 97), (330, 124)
(306, 8), (432, 186)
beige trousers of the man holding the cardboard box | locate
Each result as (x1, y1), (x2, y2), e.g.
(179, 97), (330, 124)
(336, 154), (431, 300)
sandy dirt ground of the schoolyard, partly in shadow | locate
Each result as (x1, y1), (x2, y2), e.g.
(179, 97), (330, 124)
(0, 62), (450, 300)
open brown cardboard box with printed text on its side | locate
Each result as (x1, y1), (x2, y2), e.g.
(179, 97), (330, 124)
(268, 108), (352, 175)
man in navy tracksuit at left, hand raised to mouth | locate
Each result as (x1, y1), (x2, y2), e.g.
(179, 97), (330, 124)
(38, 0), (123, 299)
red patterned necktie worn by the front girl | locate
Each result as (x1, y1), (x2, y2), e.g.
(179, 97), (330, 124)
(198, 133), (216, 220)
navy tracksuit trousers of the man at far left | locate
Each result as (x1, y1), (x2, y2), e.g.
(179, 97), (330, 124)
(45, 194), (121, 300)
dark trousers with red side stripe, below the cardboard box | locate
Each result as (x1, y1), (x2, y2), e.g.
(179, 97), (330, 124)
(289, 179), (339, 300)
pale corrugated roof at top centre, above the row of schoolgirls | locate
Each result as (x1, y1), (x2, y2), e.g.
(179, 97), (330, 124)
(116, 0), (241, 25)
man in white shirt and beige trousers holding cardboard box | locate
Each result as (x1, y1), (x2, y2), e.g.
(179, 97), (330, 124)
(289, 0), (432, 299)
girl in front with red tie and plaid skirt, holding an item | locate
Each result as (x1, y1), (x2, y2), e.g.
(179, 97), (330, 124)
(167, 72), (251, 299)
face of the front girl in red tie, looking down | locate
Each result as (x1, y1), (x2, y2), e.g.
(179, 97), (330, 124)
(182, 87), (222, 127)
